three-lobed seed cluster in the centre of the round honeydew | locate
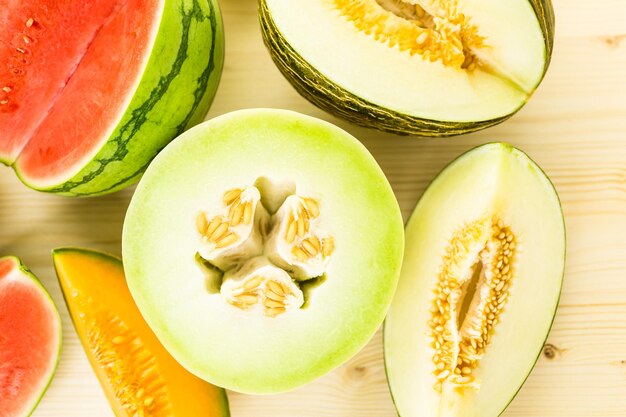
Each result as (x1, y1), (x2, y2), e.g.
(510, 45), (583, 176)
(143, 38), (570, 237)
(196, 186), (335, 317)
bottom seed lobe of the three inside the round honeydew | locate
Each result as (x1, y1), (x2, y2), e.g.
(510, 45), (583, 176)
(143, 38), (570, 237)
(221, 257), (304, 317)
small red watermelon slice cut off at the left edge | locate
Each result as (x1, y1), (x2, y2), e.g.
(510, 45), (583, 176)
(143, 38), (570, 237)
(0, 256), (61, 417)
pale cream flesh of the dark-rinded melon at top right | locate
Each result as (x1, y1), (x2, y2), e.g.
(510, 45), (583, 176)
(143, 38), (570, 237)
(261, 0), (550, 125)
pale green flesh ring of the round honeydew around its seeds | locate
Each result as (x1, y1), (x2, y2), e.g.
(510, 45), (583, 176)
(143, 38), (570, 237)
(123, 110), (403, 393)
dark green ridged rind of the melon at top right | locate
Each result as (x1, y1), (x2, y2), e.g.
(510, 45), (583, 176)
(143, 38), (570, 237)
(259, 0), (555, 138)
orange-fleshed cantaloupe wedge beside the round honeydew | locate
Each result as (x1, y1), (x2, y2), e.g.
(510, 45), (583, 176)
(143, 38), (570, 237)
(53, 249), (230, 417)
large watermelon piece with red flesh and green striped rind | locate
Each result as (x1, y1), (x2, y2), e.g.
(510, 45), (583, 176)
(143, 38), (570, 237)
(0, 0), (224, 195)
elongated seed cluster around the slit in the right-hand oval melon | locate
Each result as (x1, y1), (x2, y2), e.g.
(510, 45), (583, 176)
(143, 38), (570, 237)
(429, 219), (516, 392)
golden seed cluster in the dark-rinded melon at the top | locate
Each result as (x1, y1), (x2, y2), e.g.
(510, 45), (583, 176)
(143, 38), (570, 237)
(333, 0), (484, 71)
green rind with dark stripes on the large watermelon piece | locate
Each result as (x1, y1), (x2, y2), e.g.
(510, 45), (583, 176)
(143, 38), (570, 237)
(15, 0), (224, 196)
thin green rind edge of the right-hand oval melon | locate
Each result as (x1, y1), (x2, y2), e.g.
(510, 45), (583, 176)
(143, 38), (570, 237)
(383, 143), (567, 417)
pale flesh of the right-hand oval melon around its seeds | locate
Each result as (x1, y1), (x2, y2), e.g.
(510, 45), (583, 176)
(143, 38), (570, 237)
(384, 143), (565, 417)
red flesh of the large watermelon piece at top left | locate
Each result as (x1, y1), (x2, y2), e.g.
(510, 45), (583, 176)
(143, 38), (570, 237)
(0, 0), (162, 181)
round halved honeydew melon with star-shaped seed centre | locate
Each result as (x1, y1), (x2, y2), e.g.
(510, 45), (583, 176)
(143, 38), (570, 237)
(123, 109), (404, 393)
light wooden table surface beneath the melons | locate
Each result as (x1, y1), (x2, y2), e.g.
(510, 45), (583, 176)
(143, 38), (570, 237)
(0, 0), (626, 417)
